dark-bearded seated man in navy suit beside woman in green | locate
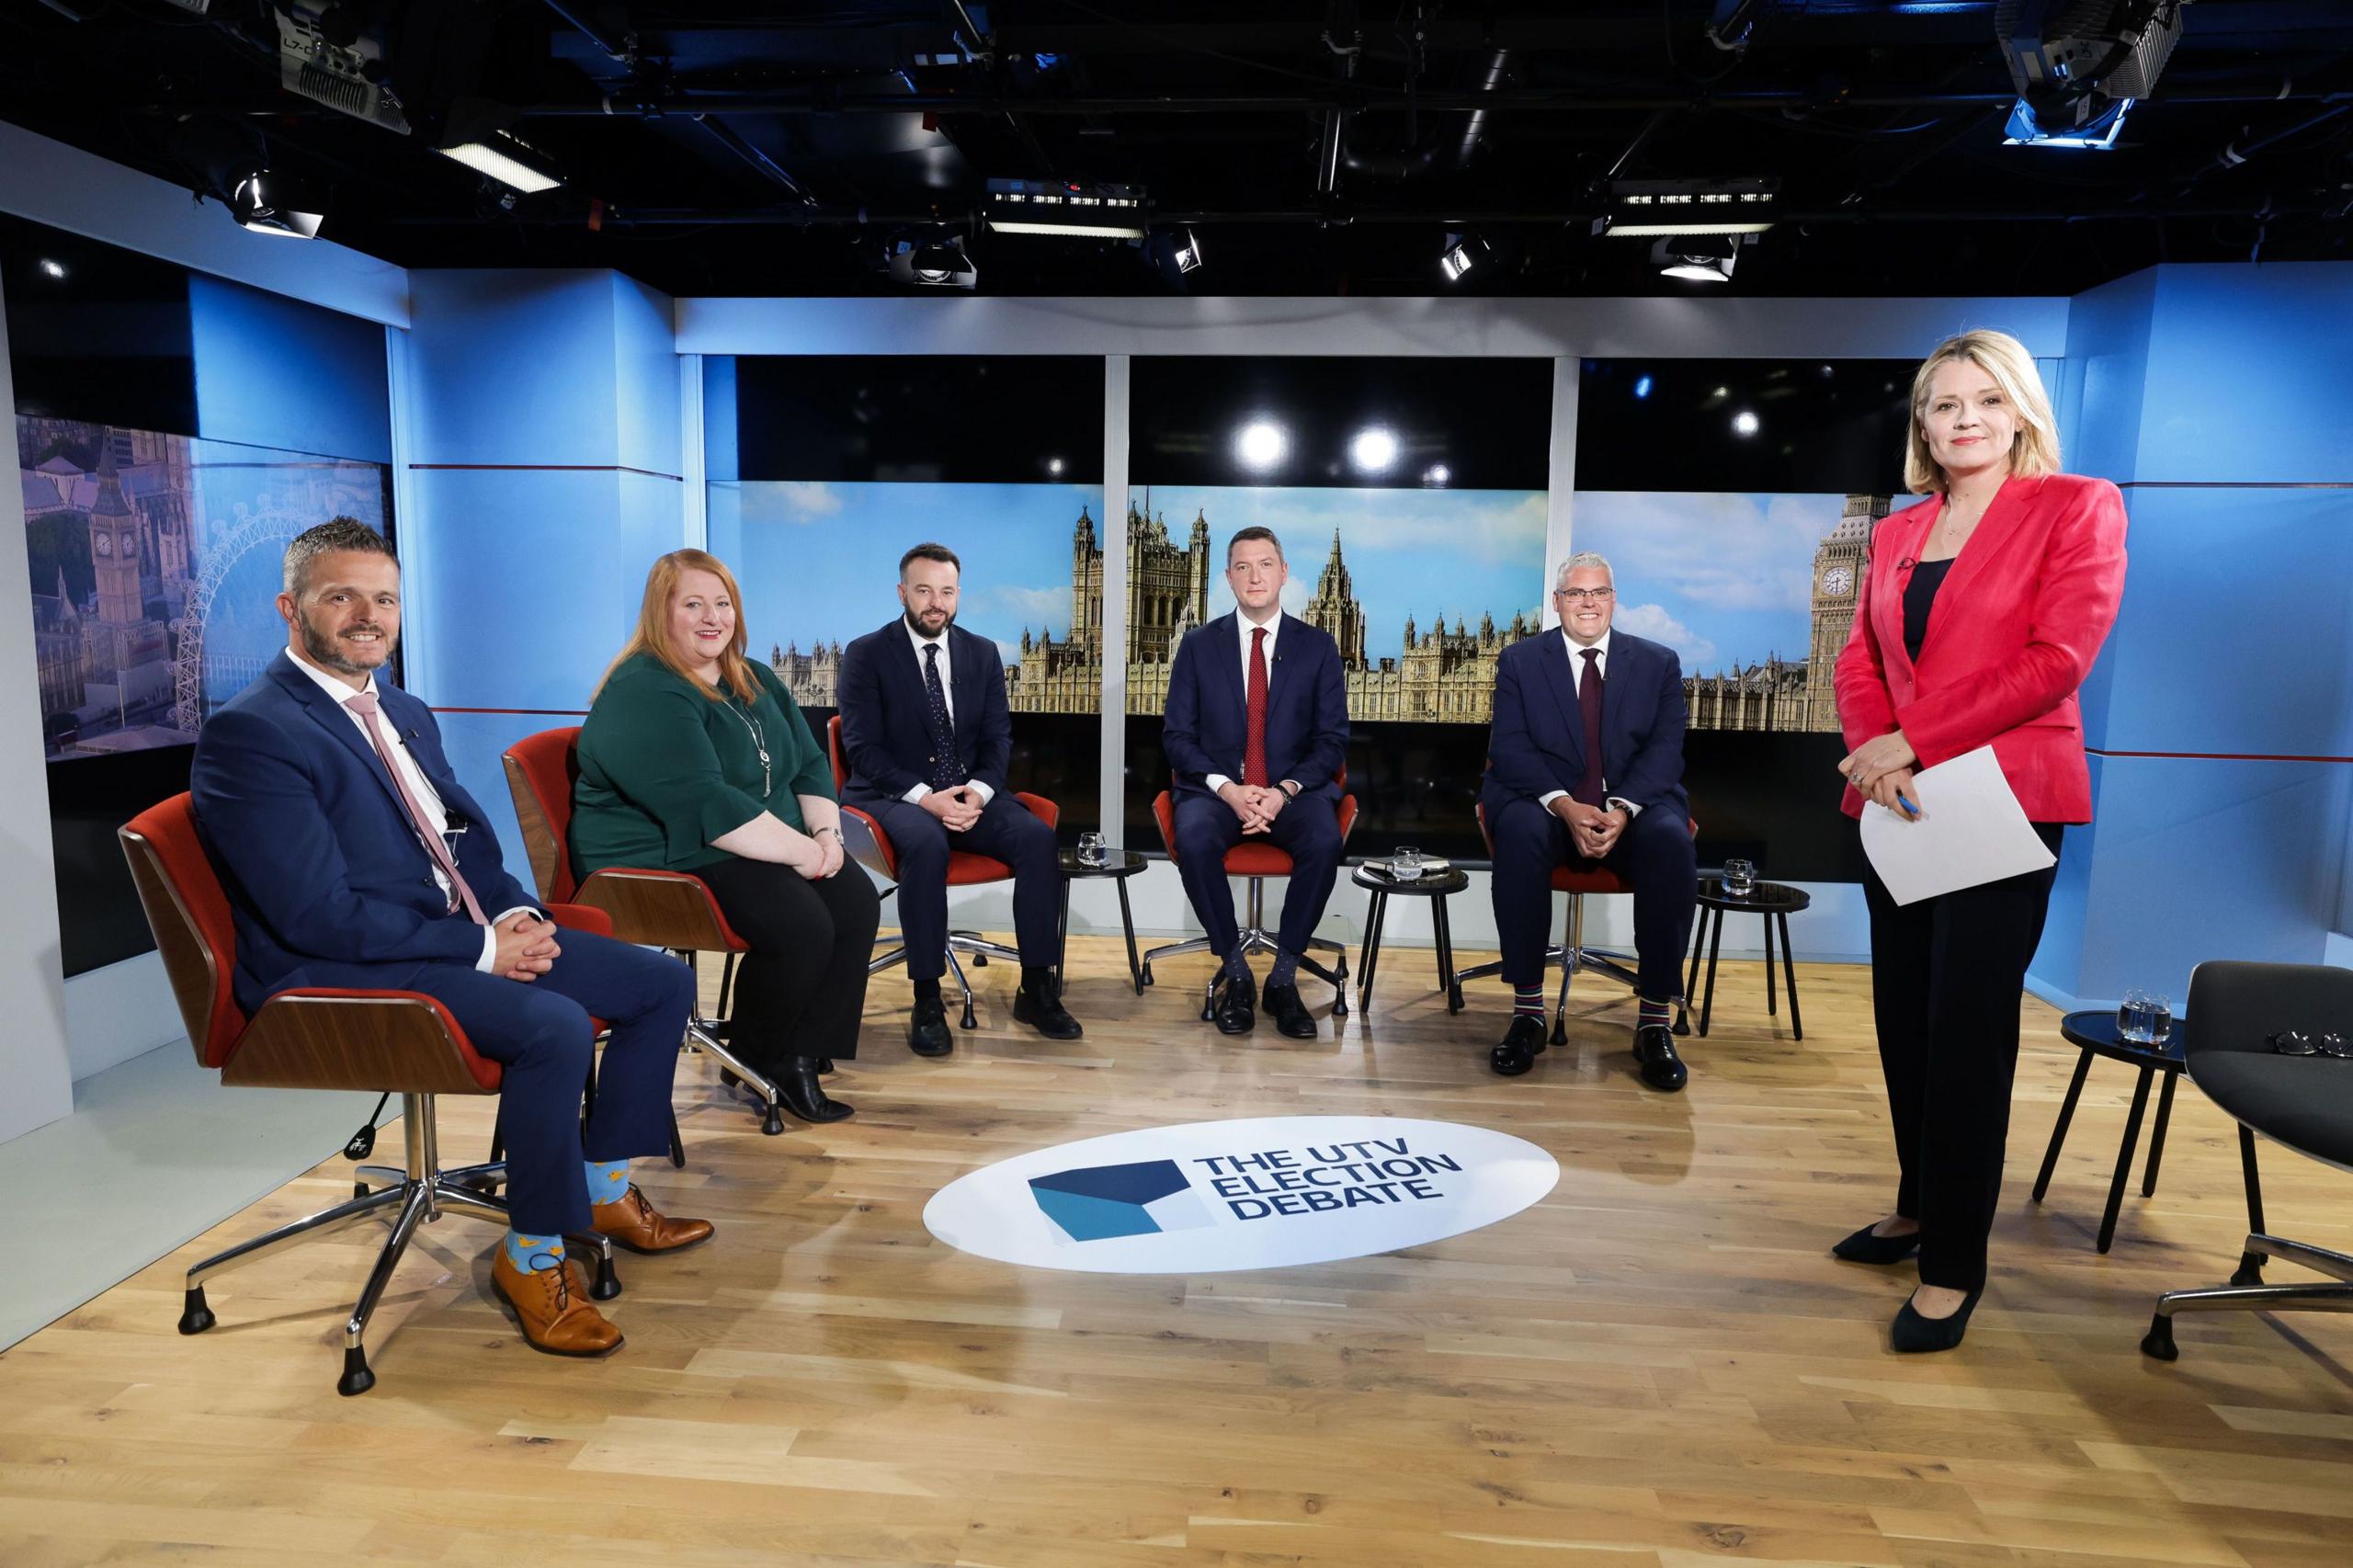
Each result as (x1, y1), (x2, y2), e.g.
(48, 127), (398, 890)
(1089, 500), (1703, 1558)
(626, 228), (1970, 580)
(840, 544), (1085, 1057)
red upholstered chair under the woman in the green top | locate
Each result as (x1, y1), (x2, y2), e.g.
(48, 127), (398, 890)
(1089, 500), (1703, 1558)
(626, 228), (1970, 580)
(501, 725), (783, 1130)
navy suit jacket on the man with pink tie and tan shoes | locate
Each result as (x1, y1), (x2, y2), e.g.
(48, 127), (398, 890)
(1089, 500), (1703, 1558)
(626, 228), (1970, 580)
(188, 653), (539, 1010)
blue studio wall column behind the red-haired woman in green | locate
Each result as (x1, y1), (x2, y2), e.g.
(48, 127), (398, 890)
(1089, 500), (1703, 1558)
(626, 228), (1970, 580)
(400, 271), (685, 873)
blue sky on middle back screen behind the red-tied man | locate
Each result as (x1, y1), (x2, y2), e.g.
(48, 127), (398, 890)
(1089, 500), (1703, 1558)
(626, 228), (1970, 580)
(1134, 485), (1543, 662)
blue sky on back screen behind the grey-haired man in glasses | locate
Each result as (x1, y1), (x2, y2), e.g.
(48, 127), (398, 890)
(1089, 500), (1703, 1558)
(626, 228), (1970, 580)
(1570, 490), (1847, 676)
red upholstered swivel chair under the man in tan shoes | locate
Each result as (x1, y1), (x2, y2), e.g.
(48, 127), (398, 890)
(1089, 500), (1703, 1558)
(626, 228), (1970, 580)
(118, 793), (621, 1393)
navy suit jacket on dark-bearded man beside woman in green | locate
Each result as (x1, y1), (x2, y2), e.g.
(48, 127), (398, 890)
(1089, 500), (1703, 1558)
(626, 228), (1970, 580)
(835, 617), (1014, 801)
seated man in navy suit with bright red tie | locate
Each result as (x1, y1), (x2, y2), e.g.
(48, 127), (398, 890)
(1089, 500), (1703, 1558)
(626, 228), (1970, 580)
(1163, 528), (1348, 1040)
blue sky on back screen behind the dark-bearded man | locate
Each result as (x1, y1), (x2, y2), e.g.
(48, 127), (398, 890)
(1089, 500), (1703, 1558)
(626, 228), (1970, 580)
(710, 481), (1104, 659)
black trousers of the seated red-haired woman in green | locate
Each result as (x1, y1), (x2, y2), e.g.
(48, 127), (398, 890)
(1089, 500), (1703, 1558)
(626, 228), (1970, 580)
(697, 857), (882, 1066)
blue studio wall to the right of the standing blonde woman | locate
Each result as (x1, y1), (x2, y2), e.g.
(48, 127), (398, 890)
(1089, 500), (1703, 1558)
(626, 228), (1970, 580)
(2033, 264), (2353, 1006)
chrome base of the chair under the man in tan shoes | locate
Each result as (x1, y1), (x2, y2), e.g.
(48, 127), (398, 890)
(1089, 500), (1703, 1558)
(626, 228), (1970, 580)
(179, 1095), (621, 1393)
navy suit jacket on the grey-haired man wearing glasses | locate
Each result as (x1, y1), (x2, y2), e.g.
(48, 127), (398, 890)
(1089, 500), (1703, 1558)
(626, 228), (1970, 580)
(1480, 629), (1692, 819)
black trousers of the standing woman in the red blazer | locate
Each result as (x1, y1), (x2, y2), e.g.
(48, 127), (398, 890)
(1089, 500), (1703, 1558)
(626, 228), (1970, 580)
(1864, 822), (2059, 1290)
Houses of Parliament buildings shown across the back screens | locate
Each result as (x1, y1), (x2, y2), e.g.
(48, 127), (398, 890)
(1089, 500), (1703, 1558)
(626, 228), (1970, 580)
(769, 494), (1890, 733)
